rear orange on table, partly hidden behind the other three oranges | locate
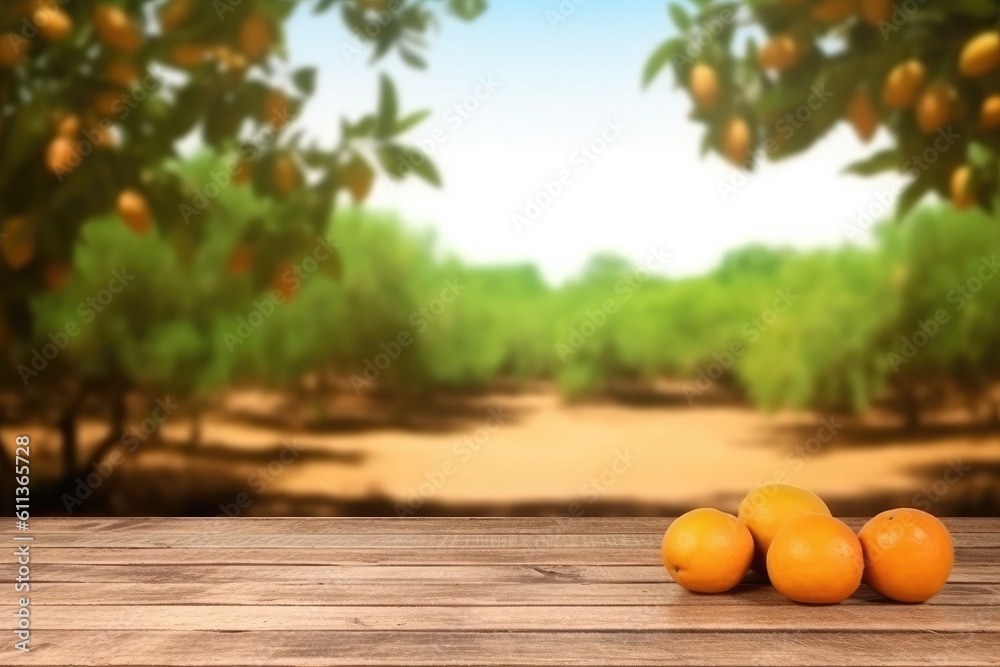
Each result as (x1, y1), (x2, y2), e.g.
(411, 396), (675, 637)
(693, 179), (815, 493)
(738, 483), (830, 576)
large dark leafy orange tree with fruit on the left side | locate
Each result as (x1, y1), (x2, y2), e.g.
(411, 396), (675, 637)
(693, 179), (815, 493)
(0, 0), (485, 482)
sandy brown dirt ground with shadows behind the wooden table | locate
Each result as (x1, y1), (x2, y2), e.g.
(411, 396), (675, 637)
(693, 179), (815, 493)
(11, 391), (1000, 516)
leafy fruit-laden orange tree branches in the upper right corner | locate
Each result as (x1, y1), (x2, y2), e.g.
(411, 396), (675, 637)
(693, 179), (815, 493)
(644, 0), (1000, 212)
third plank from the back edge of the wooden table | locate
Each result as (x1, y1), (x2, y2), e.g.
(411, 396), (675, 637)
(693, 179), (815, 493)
(21, 545), (1000, 566)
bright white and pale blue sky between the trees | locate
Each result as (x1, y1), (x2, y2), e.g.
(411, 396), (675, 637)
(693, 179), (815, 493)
(288, 0), (902, 283)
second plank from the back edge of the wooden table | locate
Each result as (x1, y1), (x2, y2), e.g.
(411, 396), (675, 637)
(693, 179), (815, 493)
(19, 524), (1000, 549)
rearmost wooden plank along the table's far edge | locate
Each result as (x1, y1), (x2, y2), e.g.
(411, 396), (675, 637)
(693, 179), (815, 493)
(17, 517), (1000, 535)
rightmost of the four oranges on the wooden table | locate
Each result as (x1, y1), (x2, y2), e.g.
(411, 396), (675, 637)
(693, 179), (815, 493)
(858, 508), (955, 602)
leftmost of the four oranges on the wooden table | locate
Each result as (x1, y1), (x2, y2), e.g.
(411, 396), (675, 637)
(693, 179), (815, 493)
(660, 508), (753, 593)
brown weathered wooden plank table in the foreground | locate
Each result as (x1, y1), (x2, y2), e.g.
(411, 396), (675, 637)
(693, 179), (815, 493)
(0, 518), (1000, 667)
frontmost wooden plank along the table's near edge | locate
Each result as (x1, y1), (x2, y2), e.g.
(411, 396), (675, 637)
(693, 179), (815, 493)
(9, 630), (1000, 667)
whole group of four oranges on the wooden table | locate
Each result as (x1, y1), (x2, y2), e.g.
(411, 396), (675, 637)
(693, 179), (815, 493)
(661, 484), (955, 604)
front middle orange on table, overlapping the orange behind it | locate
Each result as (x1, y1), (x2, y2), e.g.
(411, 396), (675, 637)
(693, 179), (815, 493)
(767, 514), (865, 604)
